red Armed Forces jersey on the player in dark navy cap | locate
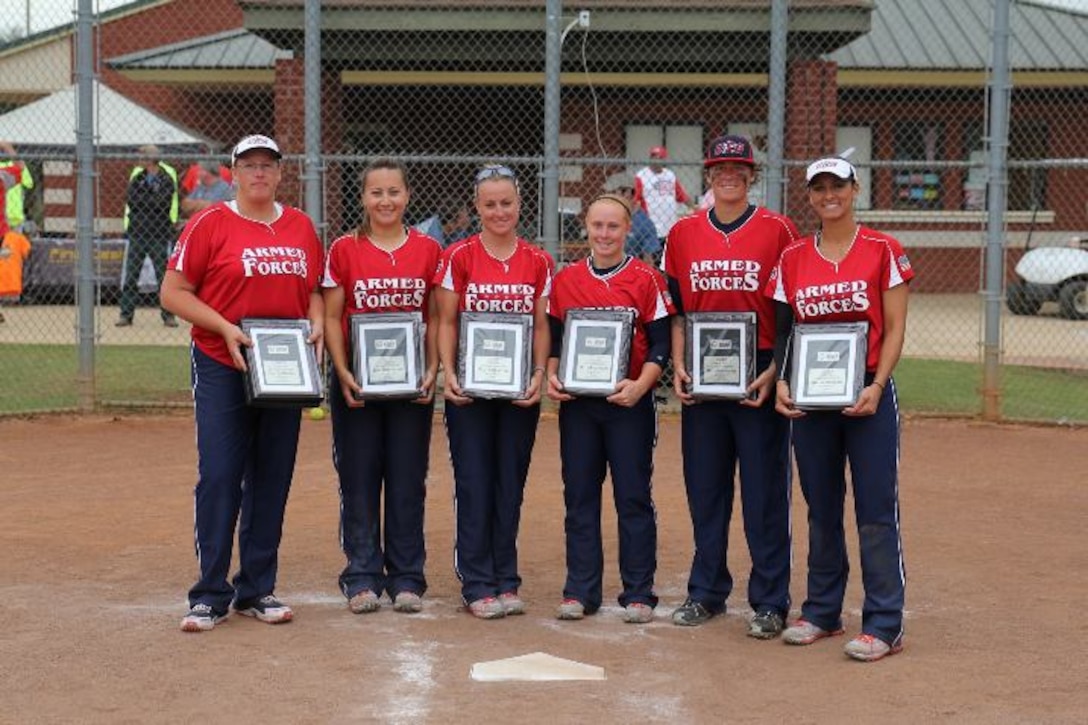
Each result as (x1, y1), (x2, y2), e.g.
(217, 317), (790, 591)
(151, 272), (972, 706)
(662, 207), (801, 349)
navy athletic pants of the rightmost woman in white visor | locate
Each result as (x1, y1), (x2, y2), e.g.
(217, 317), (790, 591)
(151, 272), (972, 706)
(793, 380), (905, 643)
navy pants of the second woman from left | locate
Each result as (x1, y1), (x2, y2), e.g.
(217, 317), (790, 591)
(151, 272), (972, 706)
(329, 385), (434, 599)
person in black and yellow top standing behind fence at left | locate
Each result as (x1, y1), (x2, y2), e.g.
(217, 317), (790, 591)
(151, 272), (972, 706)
(116, 145), (178, 328)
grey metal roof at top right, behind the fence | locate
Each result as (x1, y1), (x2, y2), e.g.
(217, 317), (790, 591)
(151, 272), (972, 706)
(827, 0), (1088, 71)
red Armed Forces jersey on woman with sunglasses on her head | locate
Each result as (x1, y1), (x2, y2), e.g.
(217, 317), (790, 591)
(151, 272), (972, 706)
(434, 234), (555, 315)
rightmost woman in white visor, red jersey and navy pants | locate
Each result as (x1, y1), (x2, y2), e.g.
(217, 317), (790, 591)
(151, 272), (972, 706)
(767, 157), (914, 662)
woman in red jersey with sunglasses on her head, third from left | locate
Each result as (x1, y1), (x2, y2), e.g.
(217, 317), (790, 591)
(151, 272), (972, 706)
(434, 165), (555, 619)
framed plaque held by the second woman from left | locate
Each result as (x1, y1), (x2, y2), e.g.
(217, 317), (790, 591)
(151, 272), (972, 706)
(348, 312), (425, 401)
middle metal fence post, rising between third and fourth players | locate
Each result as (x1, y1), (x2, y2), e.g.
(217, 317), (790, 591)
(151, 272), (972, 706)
(540, 0), (562, 262)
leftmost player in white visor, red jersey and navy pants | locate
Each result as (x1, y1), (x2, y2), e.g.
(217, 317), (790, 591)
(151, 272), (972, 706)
(161, 135), (324, 631)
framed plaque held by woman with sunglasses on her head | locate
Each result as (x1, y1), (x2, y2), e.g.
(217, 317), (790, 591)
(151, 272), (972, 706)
(457, 312), (533, 400)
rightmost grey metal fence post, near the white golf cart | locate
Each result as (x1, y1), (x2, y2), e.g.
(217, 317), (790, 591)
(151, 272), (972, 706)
(981, 0), (1012, 420)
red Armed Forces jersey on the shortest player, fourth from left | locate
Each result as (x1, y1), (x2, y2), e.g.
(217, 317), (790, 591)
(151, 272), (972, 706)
(547, 257), (676, 380)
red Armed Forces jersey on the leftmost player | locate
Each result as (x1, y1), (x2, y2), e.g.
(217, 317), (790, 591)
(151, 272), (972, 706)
(168, 201), (322, 367)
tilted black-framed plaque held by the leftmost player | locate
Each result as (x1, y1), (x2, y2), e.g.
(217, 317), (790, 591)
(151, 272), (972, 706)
(239, 319), (322, 407)
